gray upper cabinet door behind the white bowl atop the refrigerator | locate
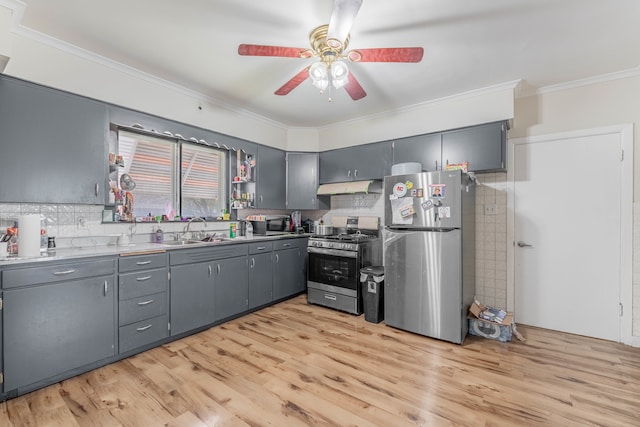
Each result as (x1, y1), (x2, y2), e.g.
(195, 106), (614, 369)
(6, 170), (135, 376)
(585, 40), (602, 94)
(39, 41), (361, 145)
(393, 134), (442, 172)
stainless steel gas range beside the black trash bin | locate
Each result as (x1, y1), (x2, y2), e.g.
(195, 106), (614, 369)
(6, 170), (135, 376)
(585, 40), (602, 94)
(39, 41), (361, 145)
(307, 217), (382, 314)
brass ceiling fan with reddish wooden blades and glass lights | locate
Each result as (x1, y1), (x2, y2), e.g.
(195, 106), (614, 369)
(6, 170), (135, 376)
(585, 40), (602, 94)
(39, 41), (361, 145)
(238, 0), (424, 101)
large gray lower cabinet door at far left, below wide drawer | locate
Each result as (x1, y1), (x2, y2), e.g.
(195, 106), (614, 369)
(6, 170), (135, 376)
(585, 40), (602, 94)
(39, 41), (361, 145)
(2, 276), (116, 391)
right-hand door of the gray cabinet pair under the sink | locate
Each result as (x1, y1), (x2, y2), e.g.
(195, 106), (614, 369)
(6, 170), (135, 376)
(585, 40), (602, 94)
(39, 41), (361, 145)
(214, 256), (249, 320)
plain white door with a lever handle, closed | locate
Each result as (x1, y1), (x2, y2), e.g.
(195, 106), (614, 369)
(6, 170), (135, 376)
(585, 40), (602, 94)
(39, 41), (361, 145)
(513, 133), (622, 341)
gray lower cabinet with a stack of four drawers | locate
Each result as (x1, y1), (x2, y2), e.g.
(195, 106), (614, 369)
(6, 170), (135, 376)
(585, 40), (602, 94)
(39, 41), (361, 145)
(118, 253), (169, 353)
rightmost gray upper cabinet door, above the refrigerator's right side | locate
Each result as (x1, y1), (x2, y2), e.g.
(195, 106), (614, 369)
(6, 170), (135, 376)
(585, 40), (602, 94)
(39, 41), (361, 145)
(442, 122), (506, 172)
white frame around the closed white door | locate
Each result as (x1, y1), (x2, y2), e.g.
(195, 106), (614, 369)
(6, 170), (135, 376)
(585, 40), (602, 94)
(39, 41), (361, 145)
(507, 123), (640, 347)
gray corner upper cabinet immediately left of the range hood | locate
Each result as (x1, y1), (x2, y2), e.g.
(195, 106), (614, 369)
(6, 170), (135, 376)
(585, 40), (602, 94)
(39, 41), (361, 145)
(287, 153), (329, 209)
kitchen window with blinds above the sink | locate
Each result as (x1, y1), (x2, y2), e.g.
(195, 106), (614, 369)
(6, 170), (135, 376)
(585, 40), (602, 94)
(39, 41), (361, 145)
(118, 129), (228, 218)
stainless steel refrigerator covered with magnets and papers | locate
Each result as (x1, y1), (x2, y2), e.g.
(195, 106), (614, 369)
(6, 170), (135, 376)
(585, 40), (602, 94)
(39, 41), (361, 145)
(383, 170), (475, 344)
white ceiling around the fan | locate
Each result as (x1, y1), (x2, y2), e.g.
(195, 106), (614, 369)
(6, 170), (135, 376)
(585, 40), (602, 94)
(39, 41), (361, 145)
(13, 0), (640, 128)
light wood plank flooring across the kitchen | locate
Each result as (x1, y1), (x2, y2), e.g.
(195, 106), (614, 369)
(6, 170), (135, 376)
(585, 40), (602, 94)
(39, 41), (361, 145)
(0, 295), (640, 427)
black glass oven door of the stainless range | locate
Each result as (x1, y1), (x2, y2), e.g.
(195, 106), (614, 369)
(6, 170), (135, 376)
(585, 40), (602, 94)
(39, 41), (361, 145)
(307, 247), (360, 292)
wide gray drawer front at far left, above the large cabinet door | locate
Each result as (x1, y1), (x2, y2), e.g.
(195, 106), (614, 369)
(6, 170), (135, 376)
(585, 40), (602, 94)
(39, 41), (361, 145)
(2, 258), (116, 289)
